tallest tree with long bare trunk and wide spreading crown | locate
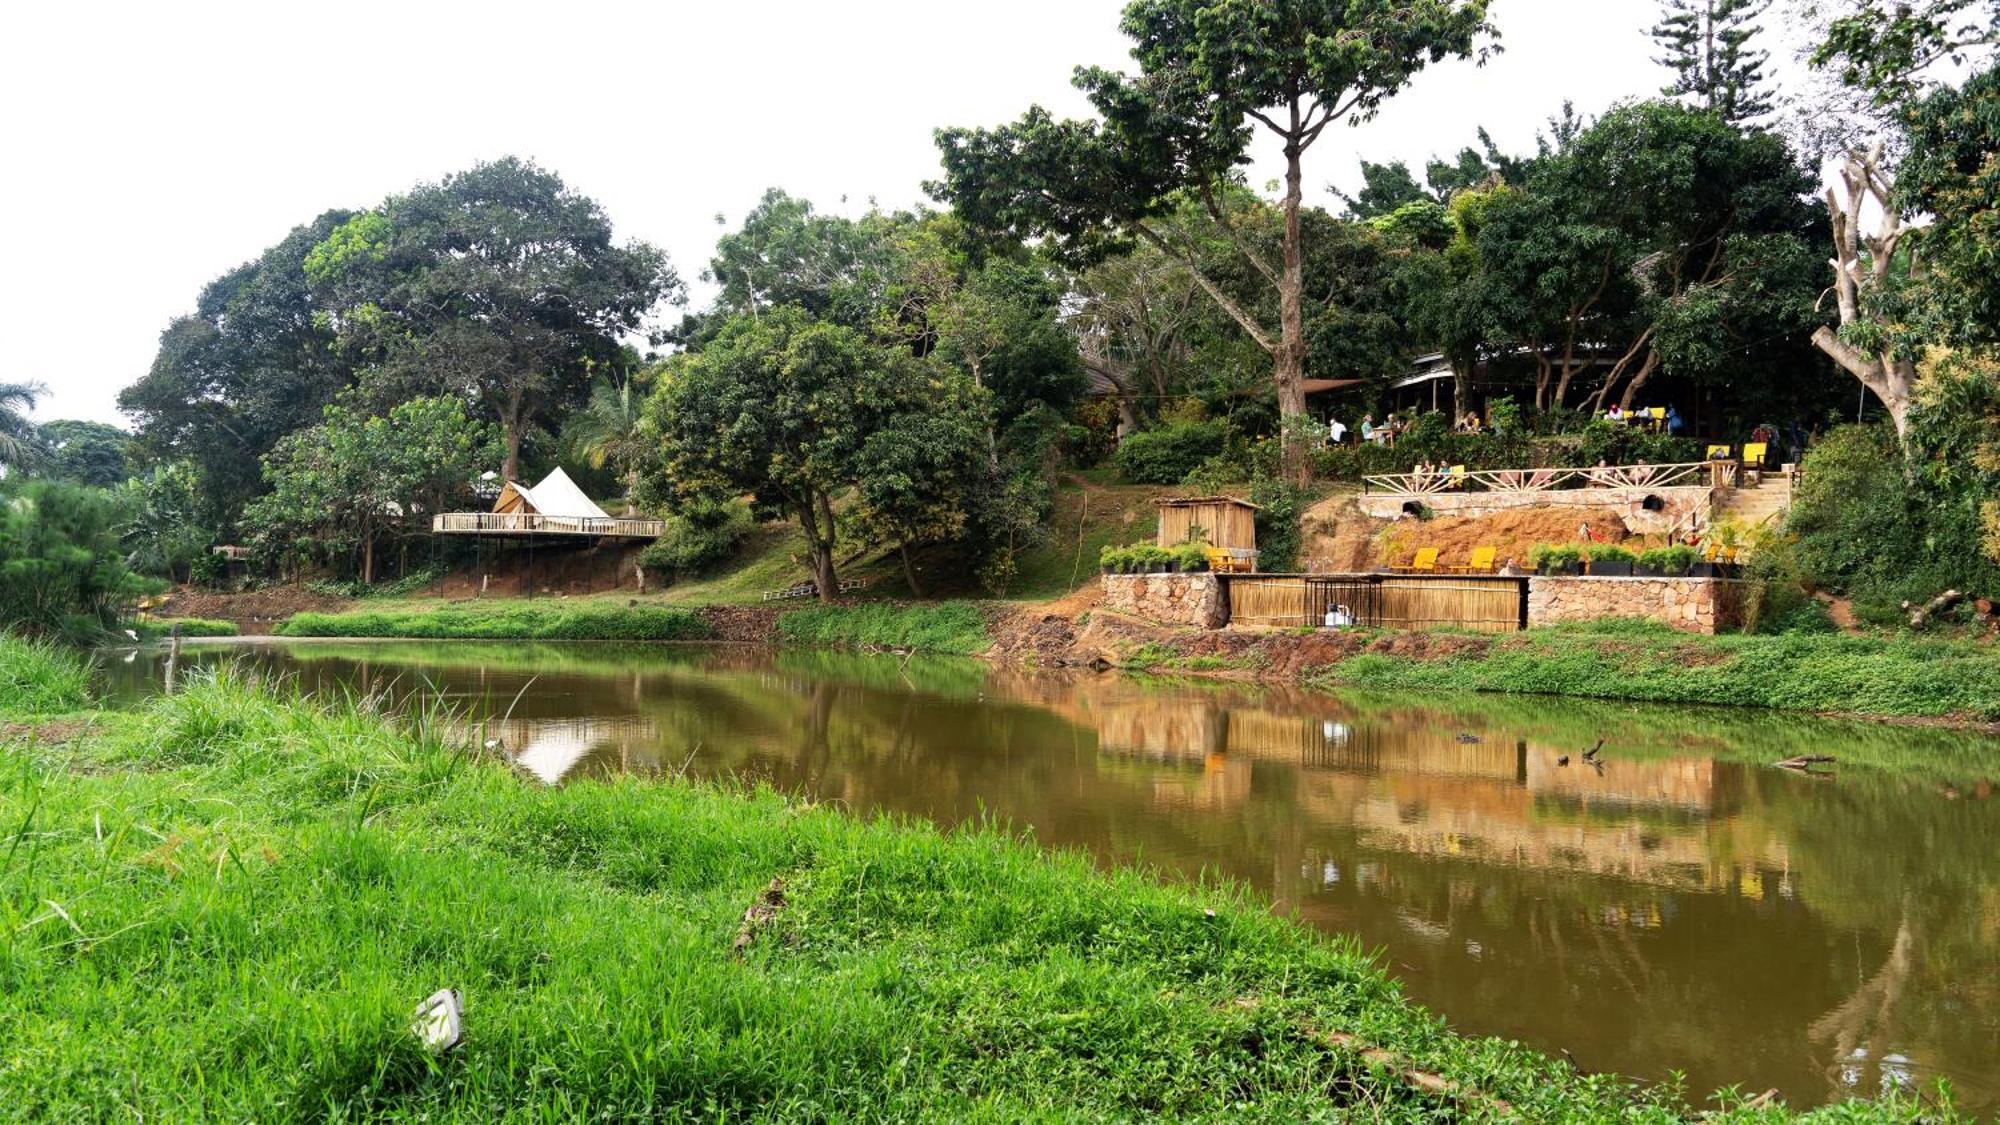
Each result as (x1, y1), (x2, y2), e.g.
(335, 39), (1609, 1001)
(934, 0), (1490, 474)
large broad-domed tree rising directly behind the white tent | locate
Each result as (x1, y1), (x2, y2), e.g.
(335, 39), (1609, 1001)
(304, 156), (682, 480)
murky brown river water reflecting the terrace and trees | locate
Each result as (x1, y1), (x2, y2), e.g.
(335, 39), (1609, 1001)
(112, 645), (2000, 1113)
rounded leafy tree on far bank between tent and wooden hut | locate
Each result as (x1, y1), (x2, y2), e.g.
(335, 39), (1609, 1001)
(646, 306), (988, 601)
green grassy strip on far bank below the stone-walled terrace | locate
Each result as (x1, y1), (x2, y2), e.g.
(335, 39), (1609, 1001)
(1316, 621), (2000, 723)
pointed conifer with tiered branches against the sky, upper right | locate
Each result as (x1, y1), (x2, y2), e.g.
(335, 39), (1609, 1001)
(1652, 0), (1774, 122)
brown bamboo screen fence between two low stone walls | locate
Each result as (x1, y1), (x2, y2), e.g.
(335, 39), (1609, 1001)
(1228, 575), (1524, 633)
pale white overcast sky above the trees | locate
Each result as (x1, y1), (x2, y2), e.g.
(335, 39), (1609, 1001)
(0, 0), (1666, 422)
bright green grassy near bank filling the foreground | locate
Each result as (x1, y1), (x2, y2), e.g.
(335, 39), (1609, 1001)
(0, 641), (1914, 1121)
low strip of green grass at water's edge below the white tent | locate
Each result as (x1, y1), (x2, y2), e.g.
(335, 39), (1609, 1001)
(278, 601), (712, 641)
